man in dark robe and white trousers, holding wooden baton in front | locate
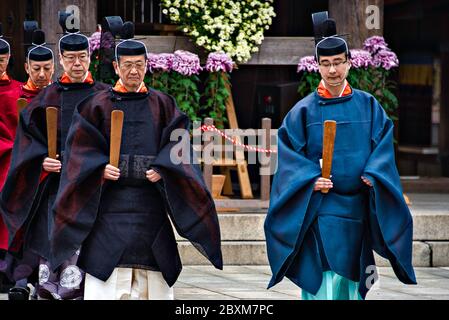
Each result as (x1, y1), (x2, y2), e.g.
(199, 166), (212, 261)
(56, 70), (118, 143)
(51, 22), (223, 300)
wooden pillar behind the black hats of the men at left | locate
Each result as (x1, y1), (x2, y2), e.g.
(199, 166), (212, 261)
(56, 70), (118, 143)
(40, 0), (97, 78)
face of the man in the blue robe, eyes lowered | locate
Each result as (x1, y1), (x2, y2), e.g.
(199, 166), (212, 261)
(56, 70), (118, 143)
(319, 53), (351, 85)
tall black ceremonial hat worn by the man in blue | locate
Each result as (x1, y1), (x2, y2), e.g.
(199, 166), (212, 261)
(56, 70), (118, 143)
(312, 11), (349, 61)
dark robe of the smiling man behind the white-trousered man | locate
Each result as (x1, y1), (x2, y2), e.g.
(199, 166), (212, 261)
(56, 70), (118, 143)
(0, 81), (108, 298)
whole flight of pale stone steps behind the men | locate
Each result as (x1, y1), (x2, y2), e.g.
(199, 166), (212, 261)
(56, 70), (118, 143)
(177, 193), (449, 267)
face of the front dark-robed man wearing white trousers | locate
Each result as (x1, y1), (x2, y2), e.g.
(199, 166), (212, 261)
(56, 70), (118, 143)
(114, 55), (147, 89)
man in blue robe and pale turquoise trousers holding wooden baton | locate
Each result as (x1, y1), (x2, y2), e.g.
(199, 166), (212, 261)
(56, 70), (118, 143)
(265, 13), (416, 300)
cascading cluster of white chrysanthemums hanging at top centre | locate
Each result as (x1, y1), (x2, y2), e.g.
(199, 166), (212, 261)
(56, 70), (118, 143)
(161, 0), (276, 62)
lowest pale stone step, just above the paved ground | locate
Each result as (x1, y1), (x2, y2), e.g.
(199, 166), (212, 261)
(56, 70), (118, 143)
(178, 241), (449, 267)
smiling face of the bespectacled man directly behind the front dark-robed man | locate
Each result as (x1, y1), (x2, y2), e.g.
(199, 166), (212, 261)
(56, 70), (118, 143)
(59, 50), (90, 82)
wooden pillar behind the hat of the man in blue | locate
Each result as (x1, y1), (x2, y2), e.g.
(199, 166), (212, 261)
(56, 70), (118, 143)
(329, 0), (384, 49)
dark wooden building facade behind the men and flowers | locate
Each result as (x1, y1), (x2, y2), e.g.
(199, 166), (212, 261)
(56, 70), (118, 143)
(0, 0), (449, 176)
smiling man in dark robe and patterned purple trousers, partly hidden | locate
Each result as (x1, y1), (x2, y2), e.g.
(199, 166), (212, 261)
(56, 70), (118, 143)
(0, 18), (108, 299)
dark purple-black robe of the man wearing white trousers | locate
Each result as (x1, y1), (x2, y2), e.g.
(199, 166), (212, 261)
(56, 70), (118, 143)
(50, 90), (223, 286)
